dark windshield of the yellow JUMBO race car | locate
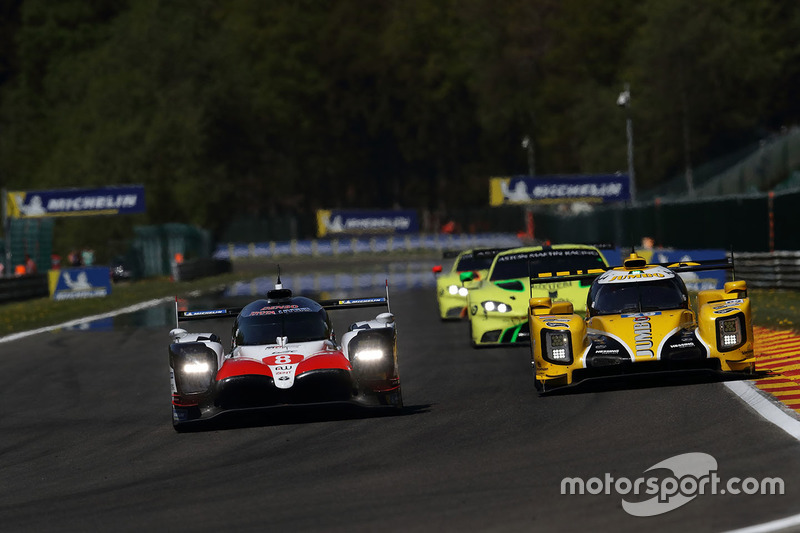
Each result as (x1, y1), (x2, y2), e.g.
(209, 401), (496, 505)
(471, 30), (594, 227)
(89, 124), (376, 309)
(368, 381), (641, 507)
(589, 276), (689, 315)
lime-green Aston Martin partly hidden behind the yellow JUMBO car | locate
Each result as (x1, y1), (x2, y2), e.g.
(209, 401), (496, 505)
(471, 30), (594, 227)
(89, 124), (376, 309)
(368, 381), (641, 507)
(465, 244), (608, 348)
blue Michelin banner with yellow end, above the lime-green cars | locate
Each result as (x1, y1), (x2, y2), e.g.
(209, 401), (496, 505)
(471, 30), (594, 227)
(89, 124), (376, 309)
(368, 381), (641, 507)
(489, 174), (631, 206)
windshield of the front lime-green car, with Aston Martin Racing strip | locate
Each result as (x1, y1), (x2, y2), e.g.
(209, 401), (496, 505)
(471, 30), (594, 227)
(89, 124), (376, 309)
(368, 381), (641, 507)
(489, 248), (605, 281)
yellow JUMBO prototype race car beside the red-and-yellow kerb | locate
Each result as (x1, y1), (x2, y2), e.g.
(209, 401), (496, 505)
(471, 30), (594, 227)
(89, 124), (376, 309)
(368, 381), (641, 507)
(528, 249), (755, 392)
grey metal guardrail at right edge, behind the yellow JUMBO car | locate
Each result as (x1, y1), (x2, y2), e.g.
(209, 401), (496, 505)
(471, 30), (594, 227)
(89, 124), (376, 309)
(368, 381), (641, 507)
(733, 251), (800, 290)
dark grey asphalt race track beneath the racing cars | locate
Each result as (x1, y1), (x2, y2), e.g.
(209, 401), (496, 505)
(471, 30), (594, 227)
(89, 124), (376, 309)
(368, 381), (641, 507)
(0, 282), (800, 532)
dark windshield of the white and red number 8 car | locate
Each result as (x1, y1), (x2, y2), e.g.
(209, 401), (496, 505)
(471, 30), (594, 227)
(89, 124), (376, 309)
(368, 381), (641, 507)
(234, 303), (331, 346)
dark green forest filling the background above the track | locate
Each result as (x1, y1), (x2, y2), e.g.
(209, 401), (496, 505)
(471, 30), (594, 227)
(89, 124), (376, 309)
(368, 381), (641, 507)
(0, 0), (800, 258)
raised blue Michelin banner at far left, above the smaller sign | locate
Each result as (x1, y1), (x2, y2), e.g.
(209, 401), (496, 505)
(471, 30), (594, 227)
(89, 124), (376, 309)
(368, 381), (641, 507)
(7, 185), (145, 218)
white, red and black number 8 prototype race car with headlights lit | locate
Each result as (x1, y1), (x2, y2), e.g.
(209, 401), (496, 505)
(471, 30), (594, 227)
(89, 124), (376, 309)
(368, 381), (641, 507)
(169, 279), (403, 431)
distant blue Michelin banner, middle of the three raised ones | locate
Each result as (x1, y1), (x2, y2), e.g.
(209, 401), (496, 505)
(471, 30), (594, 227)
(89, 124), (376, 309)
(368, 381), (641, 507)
(317, 209), (419, 238)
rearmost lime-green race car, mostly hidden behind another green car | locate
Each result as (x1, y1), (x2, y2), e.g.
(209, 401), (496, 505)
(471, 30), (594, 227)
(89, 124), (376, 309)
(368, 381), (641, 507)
(433, 248), (507, 320)
